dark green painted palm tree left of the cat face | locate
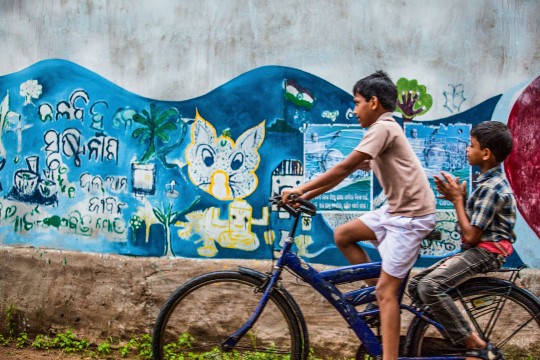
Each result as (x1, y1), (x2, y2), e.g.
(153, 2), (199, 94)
(132, 104), (179, 164)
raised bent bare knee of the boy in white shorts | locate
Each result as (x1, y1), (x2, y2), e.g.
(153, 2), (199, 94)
(334, 219), (377, 286)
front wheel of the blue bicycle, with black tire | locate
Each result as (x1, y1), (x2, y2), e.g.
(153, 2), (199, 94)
(152, 271), (309, 360)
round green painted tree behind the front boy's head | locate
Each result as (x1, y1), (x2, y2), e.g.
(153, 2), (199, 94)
(396, 78), (433, 121)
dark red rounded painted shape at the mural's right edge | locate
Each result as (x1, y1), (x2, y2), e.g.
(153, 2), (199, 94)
(504, 76), (540, 237)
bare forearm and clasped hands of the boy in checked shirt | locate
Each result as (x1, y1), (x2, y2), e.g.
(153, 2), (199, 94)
(433, 172), (483, 246)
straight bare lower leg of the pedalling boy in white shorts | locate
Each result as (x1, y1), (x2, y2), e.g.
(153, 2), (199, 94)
(377, 270), (402, 360)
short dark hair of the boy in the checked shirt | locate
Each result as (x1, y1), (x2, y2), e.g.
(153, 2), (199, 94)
(471, 121), (513, 163)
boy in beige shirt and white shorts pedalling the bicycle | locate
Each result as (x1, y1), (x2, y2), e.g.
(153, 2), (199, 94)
(282, 71), (436, 360)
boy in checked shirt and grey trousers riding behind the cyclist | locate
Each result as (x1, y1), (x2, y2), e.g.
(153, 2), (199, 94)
(409, 121), (516, 360)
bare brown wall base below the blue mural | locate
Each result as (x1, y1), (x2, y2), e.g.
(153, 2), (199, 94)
(0, 247), (540, 359)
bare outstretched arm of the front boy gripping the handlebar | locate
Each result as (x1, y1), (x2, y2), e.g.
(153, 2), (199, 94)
(282, 151), (369, 202)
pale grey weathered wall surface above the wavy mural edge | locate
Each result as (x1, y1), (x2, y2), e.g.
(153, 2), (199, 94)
(0, 0), (540, 118)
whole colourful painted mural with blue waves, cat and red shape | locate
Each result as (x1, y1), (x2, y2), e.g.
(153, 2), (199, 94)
(0, 60), (540, 266)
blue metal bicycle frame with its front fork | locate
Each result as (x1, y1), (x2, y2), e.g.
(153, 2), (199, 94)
(222, 201), (464, 360)
